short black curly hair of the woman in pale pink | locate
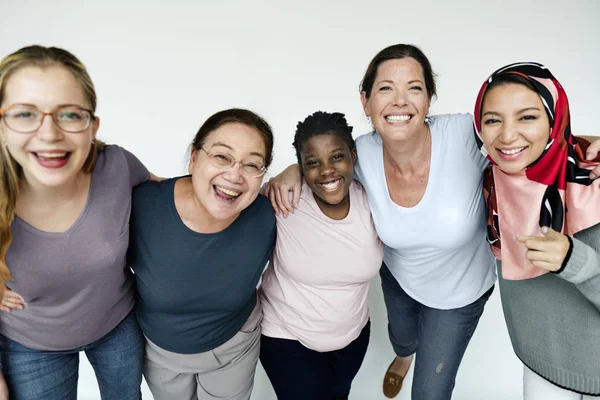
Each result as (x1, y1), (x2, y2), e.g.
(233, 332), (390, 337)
(293, 111), (356, 165)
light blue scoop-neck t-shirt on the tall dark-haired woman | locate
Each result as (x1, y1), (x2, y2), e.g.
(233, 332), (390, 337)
(355, 114), (496, 309)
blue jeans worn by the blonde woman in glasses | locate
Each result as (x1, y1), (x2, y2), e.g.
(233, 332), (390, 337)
(0, 312), (144, 400)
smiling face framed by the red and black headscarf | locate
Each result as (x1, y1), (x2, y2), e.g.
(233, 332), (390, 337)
(481, 83), (550, 174)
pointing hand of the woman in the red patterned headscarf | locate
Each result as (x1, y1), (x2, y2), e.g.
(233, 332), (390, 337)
(515, 226), (571, 271)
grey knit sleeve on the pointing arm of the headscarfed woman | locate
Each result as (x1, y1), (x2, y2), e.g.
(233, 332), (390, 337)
(556, 224), (600, 311)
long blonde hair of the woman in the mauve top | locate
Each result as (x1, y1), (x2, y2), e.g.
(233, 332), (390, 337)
(0, 46), (104, 299)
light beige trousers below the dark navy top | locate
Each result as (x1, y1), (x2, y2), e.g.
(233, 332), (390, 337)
(144, 303), (262, 400)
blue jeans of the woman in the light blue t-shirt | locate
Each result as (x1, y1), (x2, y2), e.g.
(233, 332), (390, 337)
(379, 264), (494, 400)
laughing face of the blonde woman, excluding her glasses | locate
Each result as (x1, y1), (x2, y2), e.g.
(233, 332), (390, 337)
(0, 66), (98, 187)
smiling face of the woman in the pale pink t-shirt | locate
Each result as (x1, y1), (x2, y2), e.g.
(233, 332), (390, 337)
(300, 134), (356, 214)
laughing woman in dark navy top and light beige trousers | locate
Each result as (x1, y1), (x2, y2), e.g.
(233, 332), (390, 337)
(128, 109), (276, 400)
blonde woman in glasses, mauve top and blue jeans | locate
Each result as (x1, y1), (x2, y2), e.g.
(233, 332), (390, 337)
(0, 46), (150, 400)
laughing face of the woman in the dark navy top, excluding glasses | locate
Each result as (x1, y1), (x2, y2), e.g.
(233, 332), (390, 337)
(188, 123), (266, 225)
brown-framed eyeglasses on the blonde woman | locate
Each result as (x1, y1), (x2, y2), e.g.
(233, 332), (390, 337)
(0, 104), (96, 133)
